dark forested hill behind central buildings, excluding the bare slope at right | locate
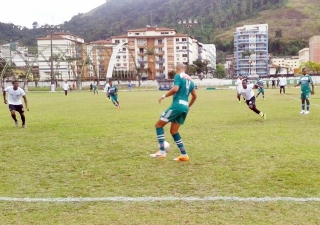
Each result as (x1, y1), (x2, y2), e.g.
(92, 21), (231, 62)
(64, 0), (285, 43)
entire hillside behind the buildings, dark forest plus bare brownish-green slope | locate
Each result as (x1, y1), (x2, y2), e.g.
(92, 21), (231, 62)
(0, 0), (320, 55)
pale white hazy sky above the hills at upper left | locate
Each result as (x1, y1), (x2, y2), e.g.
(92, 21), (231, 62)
(0, 0), (106, 28)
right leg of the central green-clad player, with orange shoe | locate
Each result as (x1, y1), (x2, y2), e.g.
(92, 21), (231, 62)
(170, 113), (189, 161)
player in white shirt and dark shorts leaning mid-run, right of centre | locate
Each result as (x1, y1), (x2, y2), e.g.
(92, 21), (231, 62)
(240, 80), (267, 120)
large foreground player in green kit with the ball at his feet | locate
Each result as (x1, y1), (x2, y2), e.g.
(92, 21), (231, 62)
(150, 63), (197, 161)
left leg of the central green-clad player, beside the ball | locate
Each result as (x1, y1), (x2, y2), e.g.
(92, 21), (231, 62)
(150, 109), (172, 158)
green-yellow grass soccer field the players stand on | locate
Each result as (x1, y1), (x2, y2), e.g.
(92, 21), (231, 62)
(0, 88), (320, 225)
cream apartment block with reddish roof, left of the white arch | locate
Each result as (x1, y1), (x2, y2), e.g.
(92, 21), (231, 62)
(37, 32), (87, 80)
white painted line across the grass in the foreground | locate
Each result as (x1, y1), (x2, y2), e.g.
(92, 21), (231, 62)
(0, 196), (320, 203)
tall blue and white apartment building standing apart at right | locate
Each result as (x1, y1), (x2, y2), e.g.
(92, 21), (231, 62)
(234, 24), (268, 76)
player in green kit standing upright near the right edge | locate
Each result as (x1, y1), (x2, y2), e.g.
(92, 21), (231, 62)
(295, 68), (314, 114)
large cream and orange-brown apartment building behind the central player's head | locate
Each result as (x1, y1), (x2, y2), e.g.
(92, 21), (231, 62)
(110, 26), (215, 79)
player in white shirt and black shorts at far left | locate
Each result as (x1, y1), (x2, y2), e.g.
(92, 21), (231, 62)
(3, 81), (29, 128)
